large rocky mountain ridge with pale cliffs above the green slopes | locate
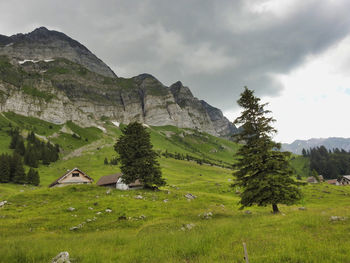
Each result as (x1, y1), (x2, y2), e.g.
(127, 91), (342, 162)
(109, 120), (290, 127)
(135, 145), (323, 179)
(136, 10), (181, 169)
(0, 27), (237, 137)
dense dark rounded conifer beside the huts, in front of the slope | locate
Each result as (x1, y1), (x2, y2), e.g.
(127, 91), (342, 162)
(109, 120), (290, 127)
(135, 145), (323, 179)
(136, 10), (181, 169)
(114, 122), (165, 188)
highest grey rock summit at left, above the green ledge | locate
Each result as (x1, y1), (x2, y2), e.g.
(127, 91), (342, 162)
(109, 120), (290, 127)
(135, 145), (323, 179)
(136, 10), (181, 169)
(0, 27), (116, 77)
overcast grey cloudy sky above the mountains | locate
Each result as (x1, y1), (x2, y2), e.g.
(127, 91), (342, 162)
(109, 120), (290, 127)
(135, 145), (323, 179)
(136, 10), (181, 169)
(0, 0), (350, 141)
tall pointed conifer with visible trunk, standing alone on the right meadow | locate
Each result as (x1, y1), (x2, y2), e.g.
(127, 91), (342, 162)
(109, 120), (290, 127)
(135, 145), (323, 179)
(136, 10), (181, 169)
(233, 88), (301, 213)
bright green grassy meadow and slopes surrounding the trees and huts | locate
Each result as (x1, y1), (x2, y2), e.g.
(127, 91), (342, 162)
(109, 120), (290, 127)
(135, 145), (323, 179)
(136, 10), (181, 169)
(0, 114), (350, 263)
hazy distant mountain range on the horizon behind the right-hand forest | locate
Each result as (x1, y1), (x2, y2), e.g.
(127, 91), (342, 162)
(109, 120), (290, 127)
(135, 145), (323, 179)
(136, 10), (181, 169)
(282, 137), (350, 154)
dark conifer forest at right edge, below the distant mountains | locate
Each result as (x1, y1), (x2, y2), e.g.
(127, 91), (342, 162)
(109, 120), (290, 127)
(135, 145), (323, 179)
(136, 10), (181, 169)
(302, 146), (350, 179)
